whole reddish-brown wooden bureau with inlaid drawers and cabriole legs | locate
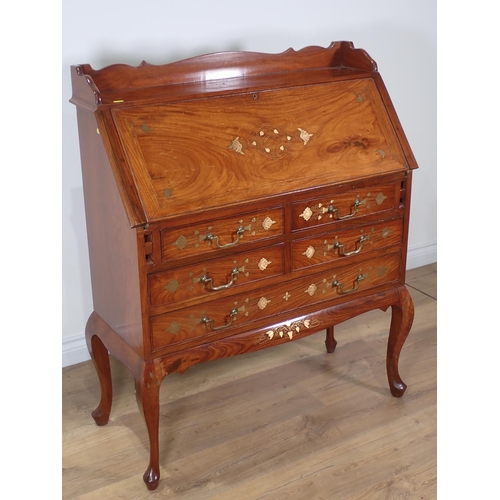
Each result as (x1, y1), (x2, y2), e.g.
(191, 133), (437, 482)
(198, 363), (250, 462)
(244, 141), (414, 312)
(71, 42), (417, 490)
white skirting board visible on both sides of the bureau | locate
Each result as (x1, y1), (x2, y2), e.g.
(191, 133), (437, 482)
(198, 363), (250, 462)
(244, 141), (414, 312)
(62, 238), (437, 368)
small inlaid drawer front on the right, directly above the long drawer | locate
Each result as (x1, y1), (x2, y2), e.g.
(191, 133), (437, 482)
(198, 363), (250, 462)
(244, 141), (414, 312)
(292, 218), (403, 270)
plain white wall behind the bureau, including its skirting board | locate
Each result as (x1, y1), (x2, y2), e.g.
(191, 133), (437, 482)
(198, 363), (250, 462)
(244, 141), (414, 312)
(62, 0), (437, 366)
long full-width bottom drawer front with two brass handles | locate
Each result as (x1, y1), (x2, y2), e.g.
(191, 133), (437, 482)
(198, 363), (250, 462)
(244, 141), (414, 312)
(151, 253), (400, 349)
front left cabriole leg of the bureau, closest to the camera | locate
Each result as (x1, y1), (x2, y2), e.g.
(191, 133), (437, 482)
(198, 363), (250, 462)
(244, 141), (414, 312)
(135, 363), (161, 490)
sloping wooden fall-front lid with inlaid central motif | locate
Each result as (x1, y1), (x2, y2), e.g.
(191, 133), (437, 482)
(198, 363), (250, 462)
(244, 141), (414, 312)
(112, 79), (408, 220)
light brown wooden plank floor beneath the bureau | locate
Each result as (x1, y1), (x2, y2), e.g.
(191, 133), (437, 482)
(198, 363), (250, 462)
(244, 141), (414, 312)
(62, 264), (437, 500)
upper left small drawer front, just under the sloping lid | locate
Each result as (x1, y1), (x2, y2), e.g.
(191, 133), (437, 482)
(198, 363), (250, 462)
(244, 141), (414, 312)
(161, 207), (284, 261)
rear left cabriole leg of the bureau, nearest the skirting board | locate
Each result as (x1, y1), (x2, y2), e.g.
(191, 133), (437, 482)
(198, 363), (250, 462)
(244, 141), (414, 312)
(85, 318), (113, 425)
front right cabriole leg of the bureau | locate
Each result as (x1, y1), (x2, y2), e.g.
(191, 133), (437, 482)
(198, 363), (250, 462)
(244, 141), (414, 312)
(387, 287), (414, 398)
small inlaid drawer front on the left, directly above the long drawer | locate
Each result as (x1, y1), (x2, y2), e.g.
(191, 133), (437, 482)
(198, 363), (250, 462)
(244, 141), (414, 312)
(149, 245), (284, 307)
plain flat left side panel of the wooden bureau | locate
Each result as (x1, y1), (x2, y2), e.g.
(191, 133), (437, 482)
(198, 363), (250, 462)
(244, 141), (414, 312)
(77, 108), (145, 357)
